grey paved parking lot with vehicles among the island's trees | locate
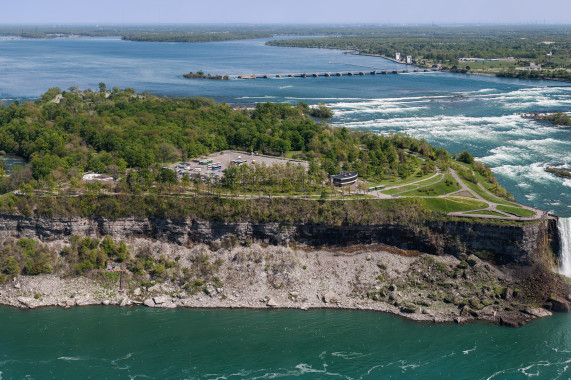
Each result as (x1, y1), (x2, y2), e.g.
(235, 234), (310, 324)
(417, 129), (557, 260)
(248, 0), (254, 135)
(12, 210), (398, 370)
(168, 151), (309, 179)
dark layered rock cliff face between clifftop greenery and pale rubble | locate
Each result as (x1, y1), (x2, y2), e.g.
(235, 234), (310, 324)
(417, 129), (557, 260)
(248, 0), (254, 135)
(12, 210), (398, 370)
(0, 215), (553, 262)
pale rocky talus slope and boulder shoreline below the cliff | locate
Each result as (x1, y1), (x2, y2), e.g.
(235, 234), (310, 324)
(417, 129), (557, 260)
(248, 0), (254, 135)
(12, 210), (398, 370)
(0, 238), (571, 326)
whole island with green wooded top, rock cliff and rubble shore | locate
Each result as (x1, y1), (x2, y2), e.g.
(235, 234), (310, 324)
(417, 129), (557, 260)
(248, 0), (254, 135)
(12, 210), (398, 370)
(0, 89), (571, 326)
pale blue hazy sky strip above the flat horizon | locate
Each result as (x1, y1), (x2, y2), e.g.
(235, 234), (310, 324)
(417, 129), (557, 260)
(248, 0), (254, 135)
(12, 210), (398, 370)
(0, 0), (571, 24)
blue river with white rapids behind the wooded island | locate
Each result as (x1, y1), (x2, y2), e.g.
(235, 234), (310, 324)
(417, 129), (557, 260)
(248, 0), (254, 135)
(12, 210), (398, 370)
(0, 38), (571, 217)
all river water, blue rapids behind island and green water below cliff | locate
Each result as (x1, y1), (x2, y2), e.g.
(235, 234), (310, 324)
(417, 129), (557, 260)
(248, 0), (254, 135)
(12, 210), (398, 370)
(0, 38), (571, 379)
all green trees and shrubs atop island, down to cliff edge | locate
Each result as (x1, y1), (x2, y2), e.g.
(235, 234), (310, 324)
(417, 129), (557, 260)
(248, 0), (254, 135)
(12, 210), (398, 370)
(0, 87), (524, 224)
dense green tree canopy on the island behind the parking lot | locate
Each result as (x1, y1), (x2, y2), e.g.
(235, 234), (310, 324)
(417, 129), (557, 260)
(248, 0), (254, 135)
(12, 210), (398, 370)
(0, 84), (449, 192)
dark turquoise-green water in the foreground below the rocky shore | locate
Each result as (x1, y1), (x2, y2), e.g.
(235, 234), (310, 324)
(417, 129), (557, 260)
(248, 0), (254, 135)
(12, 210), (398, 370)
(0, 307), (571, 379)
